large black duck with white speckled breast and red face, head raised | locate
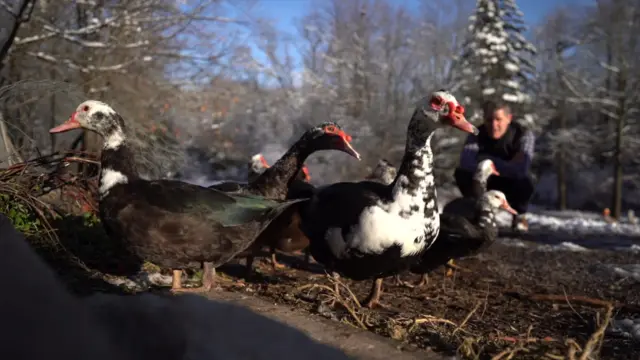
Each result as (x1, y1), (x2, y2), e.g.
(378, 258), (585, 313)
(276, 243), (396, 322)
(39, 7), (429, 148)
(301, 90), (478, 308)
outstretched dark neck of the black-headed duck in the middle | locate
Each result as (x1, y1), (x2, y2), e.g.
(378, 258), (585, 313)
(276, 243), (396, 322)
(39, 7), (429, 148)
(249, 144), (310, 200)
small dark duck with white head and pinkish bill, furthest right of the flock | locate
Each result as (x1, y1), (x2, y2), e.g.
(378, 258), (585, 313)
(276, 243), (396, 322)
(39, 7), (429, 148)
(396, 190), (518, 288)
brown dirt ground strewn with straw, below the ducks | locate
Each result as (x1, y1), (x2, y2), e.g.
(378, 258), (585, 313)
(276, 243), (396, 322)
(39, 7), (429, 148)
(209, 238), (640, 360)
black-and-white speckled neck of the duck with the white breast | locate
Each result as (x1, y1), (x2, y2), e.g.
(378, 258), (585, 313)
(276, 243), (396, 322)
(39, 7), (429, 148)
(390, 115), (439, 219)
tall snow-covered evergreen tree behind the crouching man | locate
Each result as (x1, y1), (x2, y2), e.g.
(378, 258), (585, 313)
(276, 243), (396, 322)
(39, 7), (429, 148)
(458, 0), (536, 122)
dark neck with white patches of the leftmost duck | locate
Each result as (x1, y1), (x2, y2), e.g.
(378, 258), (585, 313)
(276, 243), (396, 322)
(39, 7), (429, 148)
(99, 127), (138, 198)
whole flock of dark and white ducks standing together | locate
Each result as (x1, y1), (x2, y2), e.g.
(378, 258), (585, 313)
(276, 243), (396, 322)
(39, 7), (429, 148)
(0, 90), (515, 358)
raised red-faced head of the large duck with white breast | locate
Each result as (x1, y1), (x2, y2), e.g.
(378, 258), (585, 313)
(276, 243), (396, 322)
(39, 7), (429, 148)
(410, 89), (478, 139)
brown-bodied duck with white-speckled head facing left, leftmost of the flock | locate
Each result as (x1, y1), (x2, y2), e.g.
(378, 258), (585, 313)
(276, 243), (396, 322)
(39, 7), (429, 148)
(49, 100), (300, 293)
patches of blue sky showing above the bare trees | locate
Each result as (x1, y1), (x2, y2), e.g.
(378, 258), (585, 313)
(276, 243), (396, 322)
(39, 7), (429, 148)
(242, 0), (595, 70)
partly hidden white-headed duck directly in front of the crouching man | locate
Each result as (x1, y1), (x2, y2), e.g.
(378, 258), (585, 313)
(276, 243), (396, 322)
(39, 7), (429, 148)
(442, 159), (500, 277)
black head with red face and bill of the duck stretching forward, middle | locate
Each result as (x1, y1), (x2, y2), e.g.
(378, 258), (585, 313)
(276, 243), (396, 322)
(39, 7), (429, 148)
(300, 122), (360, 160)
